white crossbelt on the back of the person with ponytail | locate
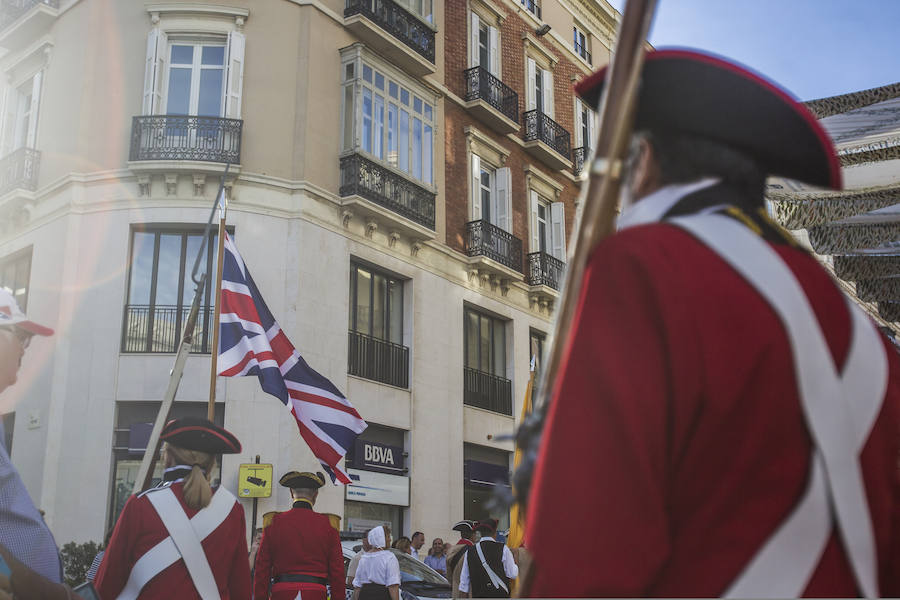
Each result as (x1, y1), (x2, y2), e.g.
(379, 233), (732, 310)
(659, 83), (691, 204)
(118, 487), (237, 600)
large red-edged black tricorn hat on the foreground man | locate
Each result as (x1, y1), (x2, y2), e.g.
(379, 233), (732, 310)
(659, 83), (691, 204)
(575, 50), (843, 190)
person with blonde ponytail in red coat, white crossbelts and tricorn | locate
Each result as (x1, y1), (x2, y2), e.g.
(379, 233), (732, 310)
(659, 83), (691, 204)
(94, 417), (250, 599)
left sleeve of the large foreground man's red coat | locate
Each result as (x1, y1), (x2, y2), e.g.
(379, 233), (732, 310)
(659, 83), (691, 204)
(526, 236), (670, 597)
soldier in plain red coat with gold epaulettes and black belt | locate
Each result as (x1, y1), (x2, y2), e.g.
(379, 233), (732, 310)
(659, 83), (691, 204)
(253, 471), (345, 600)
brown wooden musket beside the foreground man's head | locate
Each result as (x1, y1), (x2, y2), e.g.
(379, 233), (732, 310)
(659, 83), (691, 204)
(520, 0), (656, 597)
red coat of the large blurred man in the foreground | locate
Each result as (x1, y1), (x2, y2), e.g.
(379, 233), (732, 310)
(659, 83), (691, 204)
(527, 196), (900, 597)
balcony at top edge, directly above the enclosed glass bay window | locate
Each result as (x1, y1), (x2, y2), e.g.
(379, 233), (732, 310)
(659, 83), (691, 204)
(344, 0), (436, 77)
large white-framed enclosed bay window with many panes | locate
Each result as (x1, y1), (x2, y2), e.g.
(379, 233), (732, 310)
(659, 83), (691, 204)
(341, 48), (435, 185)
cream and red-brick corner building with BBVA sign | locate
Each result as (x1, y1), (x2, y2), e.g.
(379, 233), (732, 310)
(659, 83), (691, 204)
(0, 0), (619, 545)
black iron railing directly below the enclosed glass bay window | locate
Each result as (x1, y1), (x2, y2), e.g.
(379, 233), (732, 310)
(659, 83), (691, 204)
(340, 154), (435, 231)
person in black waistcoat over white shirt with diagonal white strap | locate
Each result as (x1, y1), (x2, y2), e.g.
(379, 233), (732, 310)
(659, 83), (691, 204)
(459, 519), (519, 598)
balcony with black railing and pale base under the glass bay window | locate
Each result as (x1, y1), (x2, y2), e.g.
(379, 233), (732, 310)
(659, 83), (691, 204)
(340, 154), (435, 239)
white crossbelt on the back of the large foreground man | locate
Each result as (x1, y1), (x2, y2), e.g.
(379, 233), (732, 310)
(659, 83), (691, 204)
(669, 215), (888, 598)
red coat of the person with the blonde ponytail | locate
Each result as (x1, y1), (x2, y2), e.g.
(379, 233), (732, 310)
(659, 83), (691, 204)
(94, 481), (250, 600)
